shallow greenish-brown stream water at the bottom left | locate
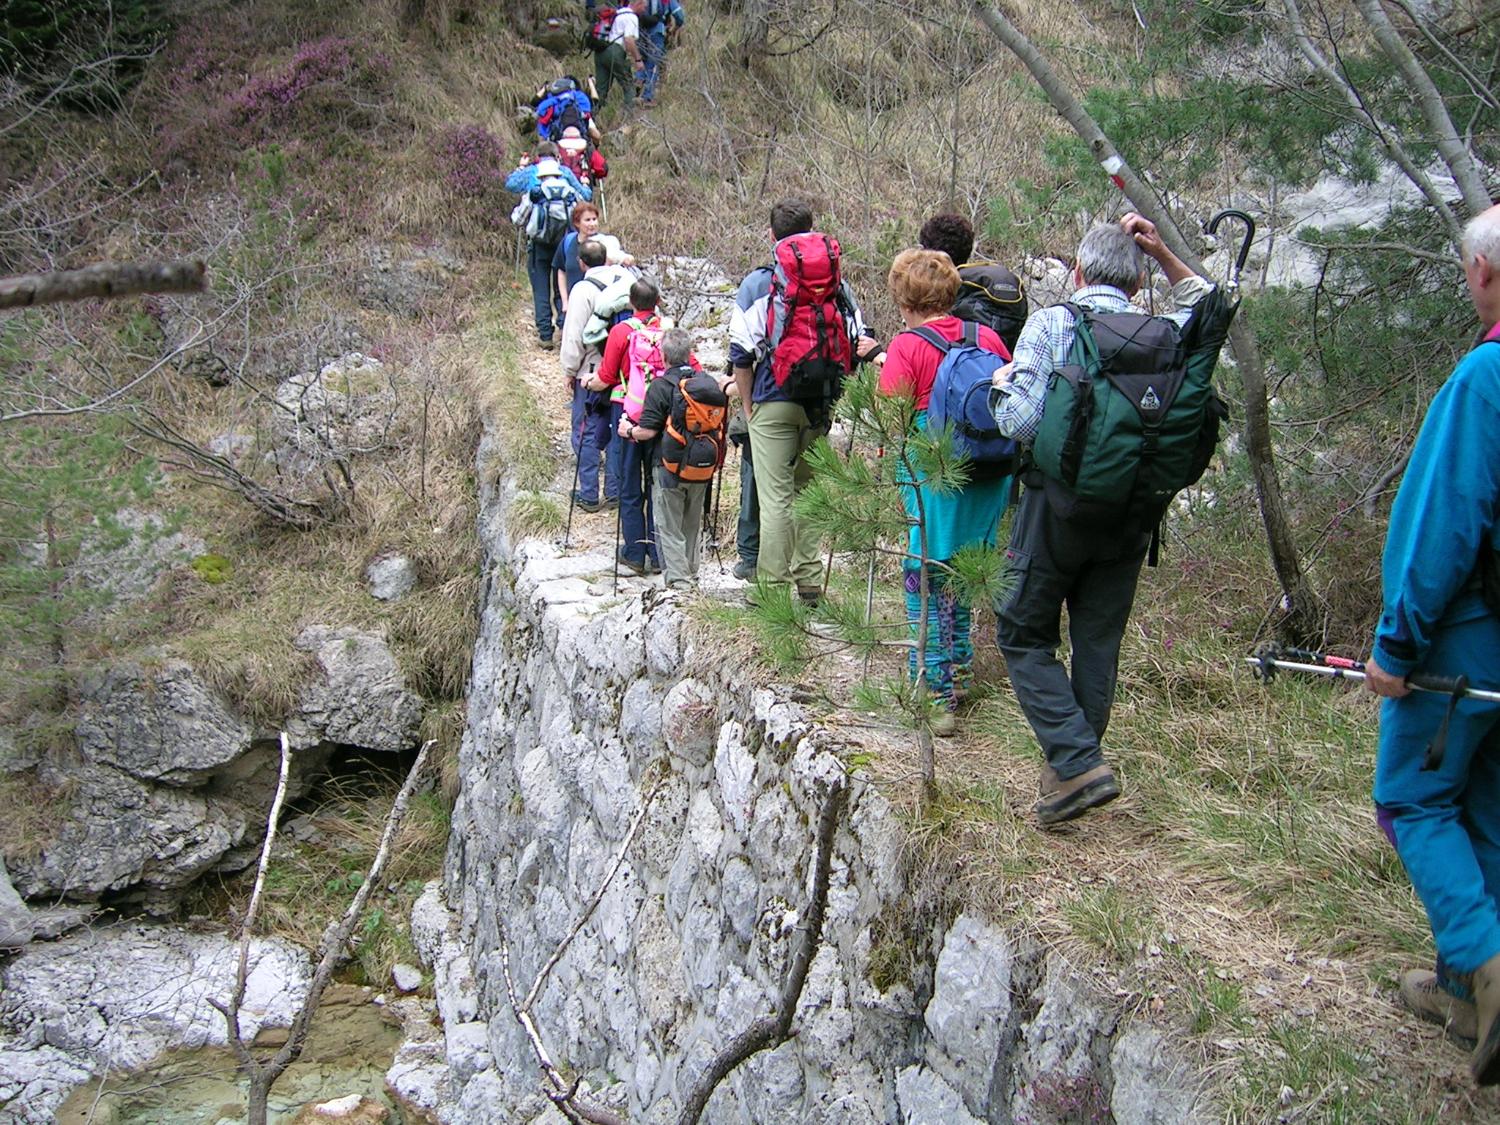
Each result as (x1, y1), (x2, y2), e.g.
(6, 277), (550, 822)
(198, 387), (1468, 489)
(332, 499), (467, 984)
(57, 984), (416, 1125)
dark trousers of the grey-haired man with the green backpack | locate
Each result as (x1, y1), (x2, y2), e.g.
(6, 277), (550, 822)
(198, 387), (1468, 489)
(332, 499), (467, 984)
(995, 488), (1151, 779)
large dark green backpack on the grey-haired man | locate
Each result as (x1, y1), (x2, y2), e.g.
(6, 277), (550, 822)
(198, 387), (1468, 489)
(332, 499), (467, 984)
(1032, 305), (1229, 527)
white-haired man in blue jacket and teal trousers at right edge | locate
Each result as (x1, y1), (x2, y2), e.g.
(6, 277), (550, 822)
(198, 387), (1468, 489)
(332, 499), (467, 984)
(1365, 207), (1500, 1086)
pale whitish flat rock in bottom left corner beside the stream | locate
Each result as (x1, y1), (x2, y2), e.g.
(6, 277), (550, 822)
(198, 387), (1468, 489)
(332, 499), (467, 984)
(0, 926), (312, 1125)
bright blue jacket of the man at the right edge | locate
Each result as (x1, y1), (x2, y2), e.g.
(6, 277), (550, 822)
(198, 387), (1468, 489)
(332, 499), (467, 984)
(1374, 333), (1500, 677)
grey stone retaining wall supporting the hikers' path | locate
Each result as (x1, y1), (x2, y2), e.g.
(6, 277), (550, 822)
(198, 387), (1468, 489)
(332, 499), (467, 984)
(411, 408), (1217, 1125)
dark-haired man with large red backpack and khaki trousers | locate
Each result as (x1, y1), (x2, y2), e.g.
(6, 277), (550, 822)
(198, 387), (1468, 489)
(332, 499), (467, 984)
(729, 200), (879, 603)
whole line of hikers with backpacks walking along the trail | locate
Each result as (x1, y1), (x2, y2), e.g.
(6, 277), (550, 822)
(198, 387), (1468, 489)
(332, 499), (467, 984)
(507, 72), (1500, 1085)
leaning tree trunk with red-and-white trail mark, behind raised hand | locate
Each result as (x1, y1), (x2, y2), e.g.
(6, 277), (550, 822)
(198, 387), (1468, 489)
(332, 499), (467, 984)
(975, 0), (1320, 641)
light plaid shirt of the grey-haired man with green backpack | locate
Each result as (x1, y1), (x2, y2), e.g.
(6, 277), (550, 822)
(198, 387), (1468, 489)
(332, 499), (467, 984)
(995, 275), (1214, 446)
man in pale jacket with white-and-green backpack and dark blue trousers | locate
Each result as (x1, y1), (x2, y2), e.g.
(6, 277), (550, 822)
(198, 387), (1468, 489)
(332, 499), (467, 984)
(560, 239), (630, 512)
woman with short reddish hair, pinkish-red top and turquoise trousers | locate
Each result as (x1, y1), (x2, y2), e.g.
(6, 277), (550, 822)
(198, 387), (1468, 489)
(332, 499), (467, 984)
(881, 251), (1016, 735)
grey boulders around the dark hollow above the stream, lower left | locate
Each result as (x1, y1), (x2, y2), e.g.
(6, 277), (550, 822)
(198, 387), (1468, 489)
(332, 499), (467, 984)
(11, 626), (423, 914)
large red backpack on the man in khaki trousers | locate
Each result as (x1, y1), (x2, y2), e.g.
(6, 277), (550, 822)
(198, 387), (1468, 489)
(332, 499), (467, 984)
(765, 231), (854, 404)
